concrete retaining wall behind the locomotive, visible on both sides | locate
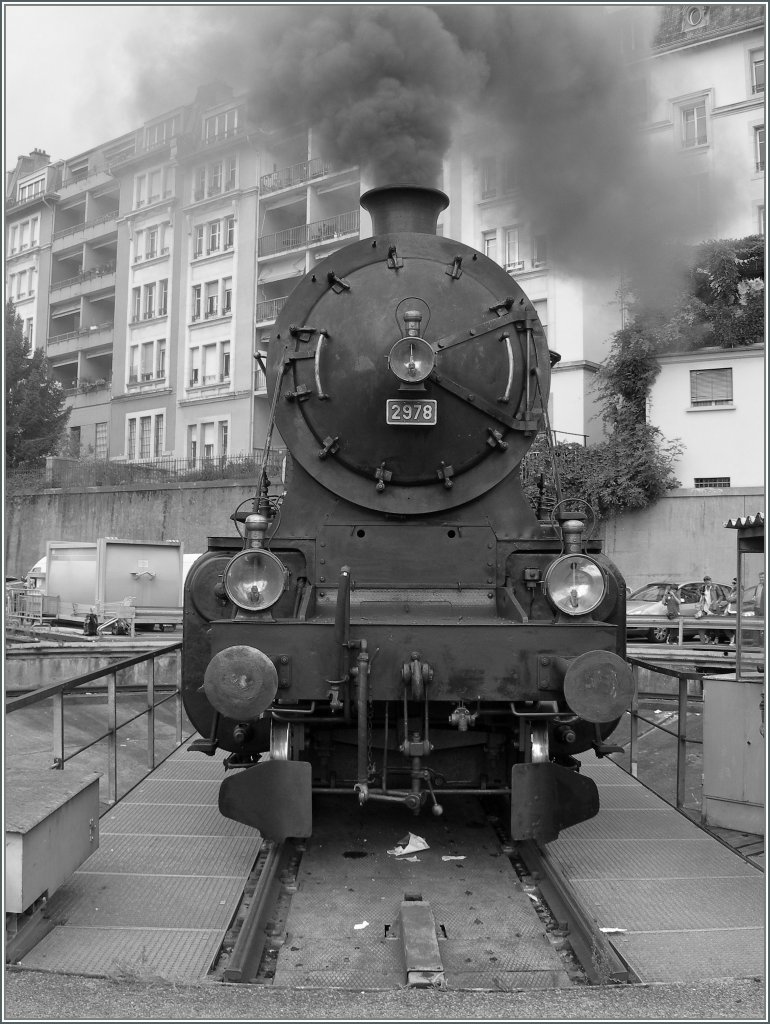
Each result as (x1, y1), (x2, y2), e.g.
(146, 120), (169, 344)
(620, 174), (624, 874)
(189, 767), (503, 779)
(5, 480), (765, 589)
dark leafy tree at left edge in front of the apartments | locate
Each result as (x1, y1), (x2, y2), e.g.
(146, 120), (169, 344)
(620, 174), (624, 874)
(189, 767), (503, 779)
(5, 301), (70, 466)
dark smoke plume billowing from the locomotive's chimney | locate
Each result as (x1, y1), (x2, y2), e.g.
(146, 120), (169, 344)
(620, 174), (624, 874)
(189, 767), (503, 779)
(134, 4), (729, 274)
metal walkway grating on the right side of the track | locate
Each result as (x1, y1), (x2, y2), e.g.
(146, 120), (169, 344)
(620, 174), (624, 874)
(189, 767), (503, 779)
(547, 759), (765, 983)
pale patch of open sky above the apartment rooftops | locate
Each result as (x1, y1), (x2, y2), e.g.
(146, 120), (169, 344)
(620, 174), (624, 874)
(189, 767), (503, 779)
(3, 3), (201, 171)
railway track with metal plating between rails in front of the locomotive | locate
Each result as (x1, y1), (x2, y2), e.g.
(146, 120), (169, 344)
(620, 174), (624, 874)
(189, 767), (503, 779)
(207, 795), (635, 991)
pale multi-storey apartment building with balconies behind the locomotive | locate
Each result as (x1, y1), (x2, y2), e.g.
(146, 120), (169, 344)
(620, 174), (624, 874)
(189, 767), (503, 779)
(5, 5), (764, 461)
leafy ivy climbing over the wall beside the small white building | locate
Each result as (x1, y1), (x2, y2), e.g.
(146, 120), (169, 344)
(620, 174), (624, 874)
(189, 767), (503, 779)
(522, 236), (765, 519)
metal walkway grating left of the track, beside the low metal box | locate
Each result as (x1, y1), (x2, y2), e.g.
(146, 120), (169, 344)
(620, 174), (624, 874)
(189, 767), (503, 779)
(22, 744), (261, 981)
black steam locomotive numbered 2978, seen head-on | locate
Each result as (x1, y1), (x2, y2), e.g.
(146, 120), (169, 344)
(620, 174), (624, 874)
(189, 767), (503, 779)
(182, 186), (632, 843)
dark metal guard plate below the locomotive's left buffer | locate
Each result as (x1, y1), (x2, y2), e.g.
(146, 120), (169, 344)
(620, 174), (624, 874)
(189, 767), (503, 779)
(219, 761), (312, 843)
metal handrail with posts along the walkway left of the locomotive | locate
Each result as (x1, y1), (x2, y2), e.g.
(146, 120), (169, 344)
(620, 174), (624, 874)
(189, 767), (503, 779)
(5, 643), (194, 806)
